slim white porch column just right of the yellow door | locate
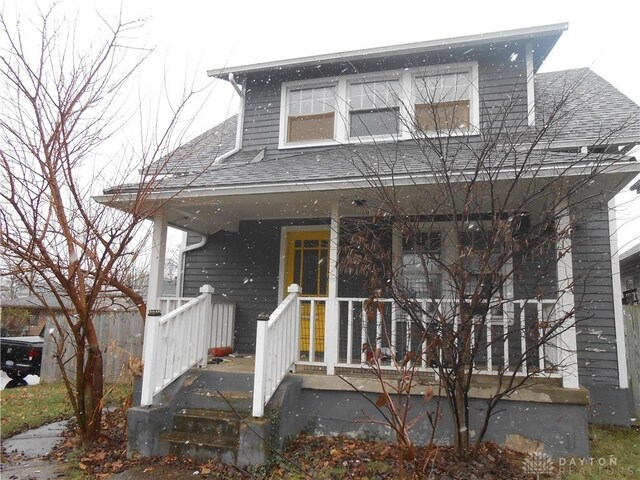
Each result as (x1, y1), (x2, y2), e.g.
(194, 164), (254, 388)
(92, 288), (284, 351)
(324, 202), (340, 375)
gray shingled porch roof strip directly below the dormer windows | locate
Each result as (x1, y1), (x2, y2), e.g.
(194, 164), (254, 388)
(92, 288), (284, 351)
(109, 141), (630, 190)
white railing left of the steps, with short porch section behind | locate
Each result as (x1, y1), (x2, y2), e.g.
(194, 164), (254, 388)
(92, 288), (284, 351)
(140, 285), (235, 405)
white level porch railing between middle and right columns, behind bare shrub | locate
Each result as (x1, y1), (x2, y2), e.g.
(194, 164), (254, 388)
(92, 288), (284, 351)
(332, 298), (564, 377)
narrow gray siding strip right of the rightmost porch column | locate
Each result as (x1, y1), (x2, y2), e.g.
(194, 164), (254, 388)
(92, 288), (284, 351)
(573, 201), (618, 387)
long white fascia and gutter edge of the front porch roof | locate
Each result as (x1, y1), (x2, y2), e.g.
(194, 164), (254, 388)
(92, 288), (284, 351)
(94, 160), (640, 210)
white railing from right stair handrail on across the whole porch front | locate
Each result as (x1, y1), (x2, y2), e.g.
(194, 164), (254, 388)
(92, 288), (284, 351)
(253, 292), (571, 417)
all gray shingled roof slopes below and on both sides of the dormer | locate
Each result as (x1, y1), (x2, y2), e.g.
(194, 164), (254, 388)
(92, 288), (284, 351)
(105, 69), (640, 194)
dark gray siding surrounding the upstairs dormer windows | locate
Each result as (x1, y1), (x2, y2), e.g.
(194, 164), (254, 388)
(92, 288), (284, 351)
(243, 44), (527, 160)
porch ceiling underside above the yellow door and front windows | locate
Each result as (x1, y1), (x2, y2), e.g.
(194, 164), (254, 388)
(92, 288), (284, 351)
(146, 165), (637, 234)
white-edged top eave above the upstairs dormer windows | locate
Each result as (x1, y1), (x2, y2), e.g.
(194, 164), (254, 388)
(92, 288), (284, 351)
(207, 22), (569, 80)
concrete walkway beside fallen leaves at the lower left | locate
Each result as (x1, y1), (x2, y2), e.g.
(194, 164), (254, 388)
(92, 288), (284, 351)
(0, 421), (67, 480)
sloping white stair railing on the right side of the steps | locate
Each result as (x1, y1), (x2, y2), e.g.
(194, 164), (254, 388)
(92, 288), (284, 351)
(252, 284), (300, 417)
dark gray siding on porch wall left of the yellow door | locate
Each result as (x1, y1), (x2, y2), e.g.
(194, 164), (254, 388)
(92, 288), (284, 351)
(184, 220), (327, 354)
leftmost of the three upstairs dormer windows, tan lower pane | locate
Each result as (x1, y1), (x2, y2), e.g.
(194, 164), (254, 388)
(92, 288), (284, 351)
(286, 85), (336, 143)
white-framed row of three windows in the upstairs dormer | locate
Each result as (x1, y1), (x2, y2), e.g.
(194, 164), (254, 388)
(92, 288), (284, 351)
(280, 62), (479, 148)
